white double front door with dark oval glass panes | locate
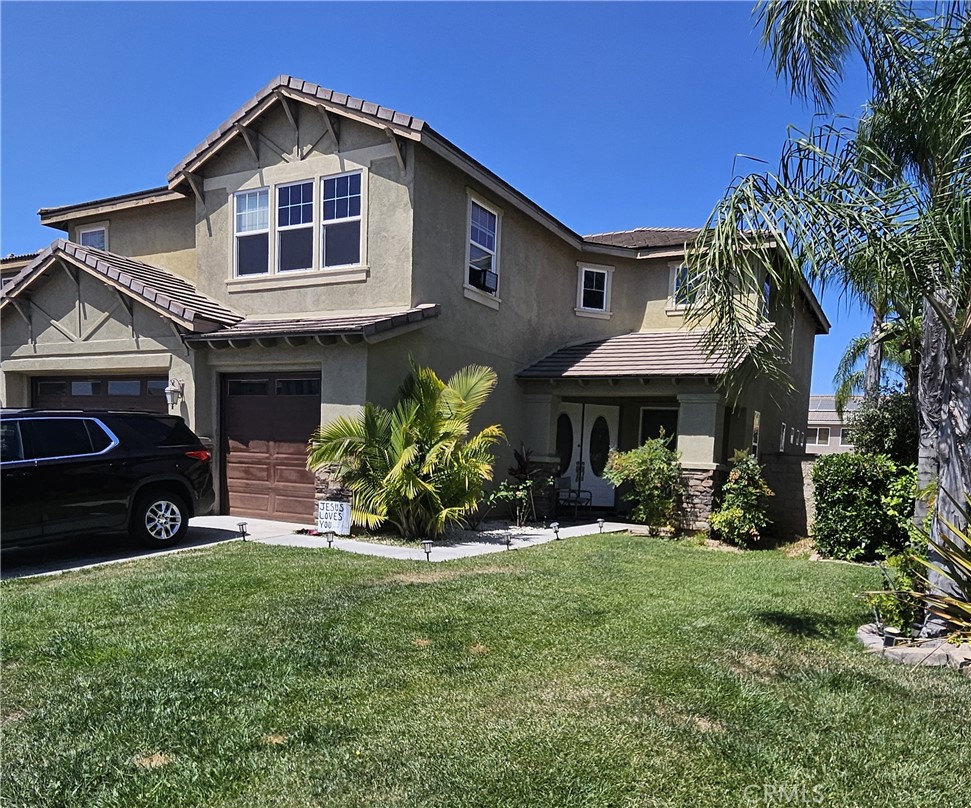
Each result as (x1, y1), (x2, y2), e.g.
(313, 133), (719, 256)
(557, 403), (620, 508)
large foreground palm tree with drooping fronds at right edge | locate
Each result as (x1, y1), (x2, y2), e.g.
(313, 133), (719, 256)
(690, 0), (971, 633)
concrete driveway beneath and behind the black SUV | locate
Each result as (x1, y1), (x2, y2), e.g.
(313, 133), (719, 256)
(0, 516), (312, 580)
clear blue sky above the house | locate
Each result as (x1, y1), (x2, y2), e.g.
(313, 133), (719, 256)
(0, 0), (867, 393)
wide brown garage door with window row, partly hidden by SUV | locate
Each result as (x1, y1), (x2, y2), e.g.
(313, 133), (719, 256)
(31, 376), (168, 413)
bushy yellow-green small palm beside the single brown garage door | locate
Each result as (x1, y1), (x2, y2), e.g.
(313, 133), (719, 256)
(307, 363), (504, 539)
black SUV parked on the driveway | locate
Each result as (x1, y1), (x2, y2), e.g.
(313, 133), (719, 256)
(0, 410), (215, 549)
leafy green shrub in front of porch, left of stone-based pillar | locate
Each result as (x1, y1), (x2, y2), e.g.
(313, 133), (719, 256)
(603, 430), (683, 529)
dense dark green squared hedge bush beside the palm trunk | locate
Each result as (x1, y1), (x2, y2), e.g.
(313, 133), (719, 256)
(813, 453), (914, 561)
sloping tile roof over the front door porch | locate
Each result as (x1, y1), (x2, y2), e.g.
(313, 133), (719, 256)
(516, 331), (760, 379)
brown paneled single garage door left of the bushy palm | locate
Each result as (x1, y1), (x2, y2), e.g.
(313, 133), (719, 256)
(222, 373), (320, 525)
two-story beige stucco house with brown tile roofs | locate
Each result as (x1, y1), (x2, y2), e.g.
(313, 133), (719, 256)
(0, 76), (828, 522)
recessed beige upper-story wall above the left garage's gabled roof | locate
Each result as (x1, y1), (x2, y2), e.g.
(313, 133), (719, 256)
(69, 197), (197, 283)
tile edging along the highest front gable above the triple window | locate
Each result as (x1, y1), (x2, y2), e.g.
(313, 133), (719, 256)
(168, 75), (425, 187)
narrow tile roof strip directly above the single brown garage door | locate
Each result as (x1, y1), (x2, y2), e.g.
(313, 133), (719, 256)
(186, 303), (441, 342)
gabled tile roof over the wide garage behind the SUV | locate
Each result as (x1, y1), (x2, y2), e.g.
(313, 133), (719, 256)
(0, 239), (243, 331)
